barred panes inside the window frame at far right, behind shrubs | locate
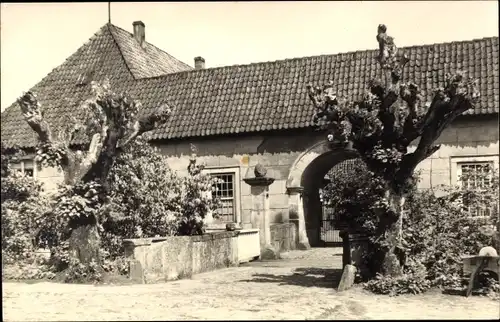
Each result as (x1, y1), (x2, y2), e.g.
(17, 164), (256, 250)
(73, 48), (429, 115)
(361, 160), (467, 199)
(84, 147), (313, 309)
(457, 161), (494, 216)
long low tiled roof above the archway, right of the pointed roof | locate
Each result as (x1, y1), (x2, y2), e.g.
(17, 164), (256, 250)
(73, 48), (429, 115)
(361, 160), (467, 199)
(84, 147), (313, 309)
(134, 37), (499, 139)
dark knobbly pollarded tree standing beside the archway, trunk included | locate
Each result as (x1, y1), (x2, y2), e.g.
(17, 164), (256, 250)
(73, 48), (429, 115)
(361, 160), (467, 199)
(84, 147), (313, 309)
(308, 25), (479, 276)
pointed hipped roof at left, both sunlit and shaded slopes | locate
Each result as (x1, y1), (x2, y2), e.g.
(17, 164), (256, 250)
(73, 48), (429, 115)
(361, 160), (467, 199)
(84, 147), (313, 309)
(1, 24), (192, 147)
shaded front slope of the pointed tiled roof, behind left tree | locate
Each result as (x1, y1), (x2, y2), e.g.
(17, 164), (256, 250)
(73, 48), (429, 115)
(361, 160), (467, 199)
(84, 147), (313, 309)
(1, 25), (134, 147)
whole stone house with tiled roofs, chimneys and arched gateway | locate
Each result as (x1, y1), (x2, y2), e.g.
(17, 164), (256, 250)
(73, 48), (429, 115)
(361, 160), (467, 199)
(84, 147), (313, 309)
(1, 22), (499, 247)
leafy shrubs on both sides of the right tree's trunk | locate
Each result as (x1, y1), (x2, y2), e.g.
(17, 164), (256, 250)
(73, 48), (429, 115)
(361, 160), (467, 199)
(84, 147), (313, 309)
(323, 157), (500, 295)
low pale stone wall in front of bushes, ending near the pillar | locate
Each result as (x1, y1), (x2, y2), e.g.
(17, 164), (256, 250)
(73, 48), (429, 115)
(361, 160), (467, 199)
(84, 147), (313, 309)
(123, 230), (259, 283)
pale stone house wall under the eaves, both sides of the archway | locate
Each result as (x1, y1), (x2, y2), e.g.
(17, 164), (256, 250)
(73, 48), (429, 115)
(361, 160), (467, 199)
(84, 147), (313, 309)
(158, 116), (499, 228)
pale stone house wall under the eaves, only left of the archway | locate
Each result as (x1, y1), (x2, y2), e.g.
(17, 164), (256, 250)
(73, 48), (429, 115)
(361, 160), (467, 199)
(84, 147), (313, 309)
(154, 130), (323, 229)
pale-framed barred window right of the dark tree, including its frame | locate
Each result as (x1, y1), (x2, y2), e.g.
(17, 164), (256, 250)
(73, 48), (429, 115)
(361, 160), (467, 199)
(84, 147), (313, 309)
(451, 156), (498, 217)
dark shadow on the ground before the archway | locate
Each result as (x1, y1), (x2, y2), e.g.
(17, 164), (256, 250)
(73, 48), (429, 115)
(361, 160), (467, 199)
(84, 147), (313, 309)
(239, 267), (342, 288)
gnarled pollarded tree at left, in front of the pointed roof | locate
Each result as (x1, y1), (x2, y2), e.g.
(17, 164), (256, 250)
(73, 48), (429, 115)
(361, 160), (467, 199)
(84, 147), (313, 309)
(18, 81), (170, 264)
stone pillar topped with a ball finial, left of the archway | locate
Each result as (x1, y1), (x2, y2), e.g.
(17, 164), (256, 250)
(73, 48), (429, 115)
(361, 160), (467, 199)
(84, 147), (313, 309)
(243, 165), (279, 259)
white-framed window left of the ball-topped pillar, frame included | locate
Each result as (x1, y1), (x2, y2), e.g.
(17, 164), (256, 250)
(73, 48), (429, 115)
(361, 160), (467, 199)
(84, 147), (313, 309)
(205, 168), (240, 223)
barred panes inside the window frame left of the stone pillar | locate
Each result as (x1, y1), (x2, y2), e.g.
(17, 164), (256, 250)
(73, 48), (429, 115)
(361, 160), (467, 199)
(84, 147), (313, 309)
(211, 173), (236, 223)
